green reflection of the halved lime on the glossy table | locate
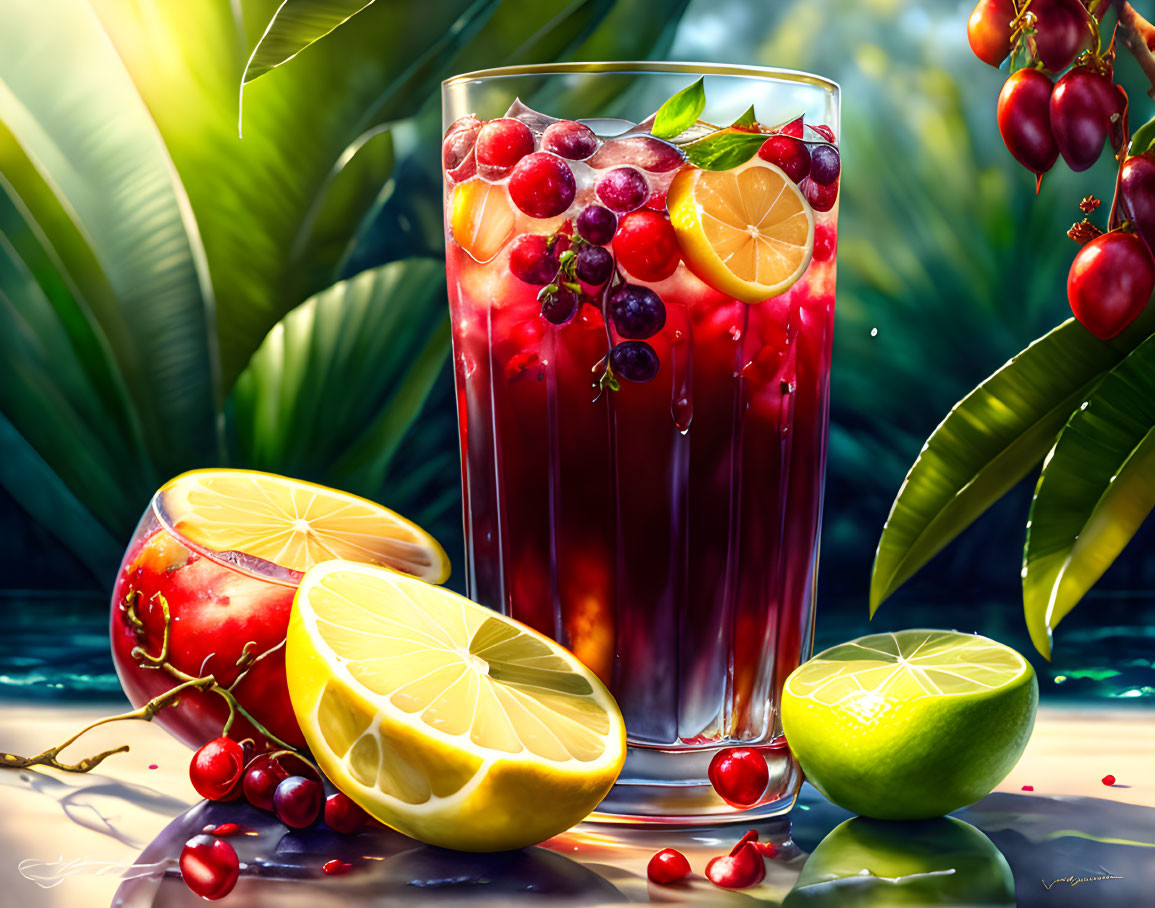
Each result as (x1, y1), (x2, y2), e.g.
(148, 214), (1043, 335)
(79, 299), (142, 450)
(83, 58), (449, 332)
(783, 817), (1015, 908)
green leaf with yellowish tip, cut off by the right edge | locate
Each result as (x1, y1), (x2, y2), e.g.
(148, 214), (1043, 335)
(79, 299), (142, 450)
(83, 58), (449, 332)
(1022, 335), (1155, 658)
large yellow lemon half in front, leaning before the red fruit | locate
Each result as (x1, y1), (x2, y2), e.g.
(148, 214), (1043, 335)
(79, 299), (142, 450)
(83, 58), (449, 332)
(285, 561), (626, 851)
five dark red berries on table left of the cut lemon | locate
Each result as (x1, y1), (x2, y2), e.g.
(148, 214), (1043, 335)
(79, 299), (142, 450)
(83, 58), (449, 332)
(180, 737), (370, 900)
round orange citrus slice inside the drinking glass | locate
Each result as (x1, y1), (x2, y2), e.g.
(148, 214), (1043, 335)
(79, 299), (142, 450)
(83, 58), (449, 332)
(666, 155), (814, 303)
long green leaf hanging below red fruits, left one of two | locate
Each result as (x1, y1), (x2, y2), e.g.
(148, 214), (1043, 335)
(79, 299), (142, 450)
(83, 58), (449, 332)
(870, 311), (1153, 615)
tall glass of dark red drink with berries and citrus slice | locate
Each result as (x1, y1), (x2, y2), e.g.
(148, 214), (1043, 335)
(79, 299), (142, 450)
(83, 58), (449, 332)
(442, 64), (841, 823)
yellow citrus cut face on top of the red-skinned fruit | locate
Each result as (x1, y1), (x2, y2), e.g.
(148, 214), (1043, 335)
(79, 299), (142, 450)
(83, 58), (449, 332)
(159, 470), (449, 583)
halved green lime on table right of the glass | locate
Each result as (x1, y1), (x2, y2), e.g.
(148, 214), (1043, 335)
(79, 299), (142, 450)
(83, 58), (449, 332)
(782, 631), (1038, 820)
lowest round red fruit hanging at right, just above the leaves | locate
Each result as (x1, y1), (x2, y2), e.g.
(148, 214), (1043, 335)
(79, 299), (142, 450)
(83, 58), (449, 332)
(1067, 231), (1155, 341)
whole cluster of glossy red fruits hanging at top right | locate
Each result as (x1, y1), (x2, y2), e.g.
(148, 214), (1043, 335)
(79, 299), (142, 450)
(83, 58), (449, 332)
(967, 0), (1155, 340)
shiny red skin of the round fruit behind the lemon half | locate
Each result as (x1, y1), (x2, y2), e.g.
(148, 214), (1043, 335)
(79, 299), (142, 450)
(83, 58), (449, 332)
(111, 524), (305, 752)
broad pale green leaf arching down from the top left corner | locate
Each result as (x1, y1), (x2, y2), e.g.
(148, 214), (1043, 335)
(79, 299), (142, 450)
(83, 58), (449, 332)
(0, 0), (218, 494)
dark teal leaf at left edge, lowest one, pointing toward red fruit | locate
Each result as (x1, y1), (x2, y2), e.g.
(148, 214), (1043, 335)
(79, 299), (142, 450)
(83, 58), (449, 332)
(0, 414), (122, 572)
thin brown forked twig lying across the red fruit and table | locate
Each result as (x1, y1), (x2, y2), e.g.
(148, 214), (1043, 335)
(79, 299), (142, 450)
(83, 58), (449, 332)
(0, 589), (302, 773)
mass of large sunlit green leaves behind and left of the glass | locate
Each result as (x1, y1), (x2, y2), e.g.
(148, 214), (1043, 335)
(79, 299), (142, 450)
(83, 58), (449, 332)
(0, 0), (685, 586)
